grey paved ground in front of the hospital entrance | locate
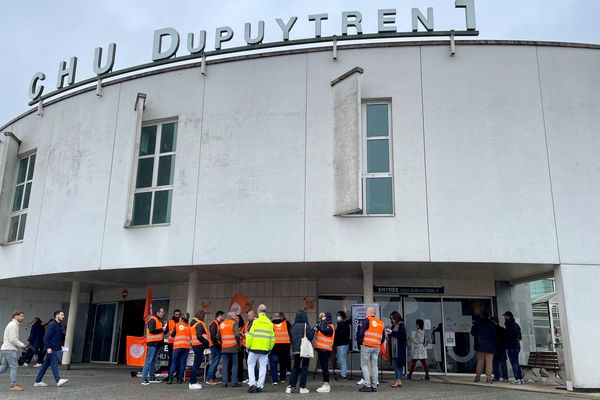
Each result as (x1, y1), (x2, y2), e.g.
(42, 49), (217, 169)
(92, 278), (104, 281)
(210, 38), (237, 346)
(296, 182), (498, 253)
(0, 364), (592, 400)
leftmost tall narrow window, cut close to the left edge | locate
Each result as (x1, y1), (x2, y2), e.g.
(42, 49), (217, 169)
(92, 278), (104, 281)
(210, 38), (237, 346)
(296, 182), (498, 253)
(7, 154), (35, 243)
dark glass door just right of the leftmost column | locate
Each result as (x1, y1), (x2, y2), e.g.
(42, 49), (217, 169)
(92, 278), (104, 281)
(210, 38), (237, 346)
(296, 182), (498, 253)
(90, 303), (119, 363)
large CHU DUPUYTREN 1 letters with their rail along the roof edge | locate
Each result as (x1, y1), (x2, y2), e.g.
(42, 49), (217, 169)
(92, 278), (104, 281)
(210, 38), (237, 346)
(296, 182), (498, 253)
(28, 0), (479, 105)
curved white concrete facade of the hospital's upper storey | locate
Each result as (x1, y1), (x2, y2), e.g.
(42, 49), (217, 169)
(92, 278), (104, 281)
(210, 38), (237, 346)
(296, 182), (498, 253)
(0, 42), (600, 389)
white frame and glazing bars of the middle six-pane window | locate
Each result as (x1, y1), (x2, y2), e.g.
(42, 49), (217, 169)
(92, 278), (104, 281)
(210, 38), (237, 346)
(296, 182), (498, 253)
(127, 117), (179, 229)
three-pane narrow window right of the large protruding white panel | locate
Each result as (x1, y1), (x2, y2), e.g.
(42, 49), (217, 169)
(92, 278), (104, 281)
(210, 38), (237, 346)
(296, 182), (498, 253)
(363, 102), (394, 215)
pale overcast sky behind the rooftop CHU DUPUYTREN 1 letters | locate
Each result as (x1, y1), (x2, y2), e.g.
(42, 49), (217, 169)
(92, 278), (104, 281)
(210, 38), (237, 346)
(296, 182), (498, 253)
(0, 0), (600, 125)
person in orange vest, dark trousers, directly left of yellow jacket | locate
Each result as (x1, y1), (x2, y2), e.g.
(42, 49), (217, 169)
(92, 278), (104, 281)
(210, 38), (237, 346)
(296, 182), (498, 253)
(217, 311), (241, 387)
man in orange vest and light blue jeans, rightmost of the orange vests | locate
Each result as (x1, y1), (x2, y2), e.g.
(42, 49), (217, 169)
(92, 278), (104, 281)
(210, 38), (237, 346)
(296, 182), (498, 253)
(356, 307), (385, 392)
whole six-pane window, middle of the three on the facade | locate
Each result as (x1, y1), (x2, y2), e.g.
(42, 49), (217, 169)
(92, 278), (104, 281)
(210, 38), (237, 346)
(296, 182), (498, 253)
(131, 121), (177, 226)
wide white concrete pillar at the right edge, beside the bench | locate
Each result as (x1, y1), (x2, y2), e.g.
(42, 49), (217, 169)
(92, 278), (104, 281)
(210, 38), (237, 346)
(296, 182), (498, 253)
(554, 264), (600, 391)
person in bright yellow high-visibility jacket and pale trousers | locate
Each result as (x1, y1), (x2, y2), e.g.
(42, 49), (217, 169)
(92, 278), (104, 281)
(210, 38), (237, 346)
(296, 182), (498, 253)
(246, 304), (275, 393)
